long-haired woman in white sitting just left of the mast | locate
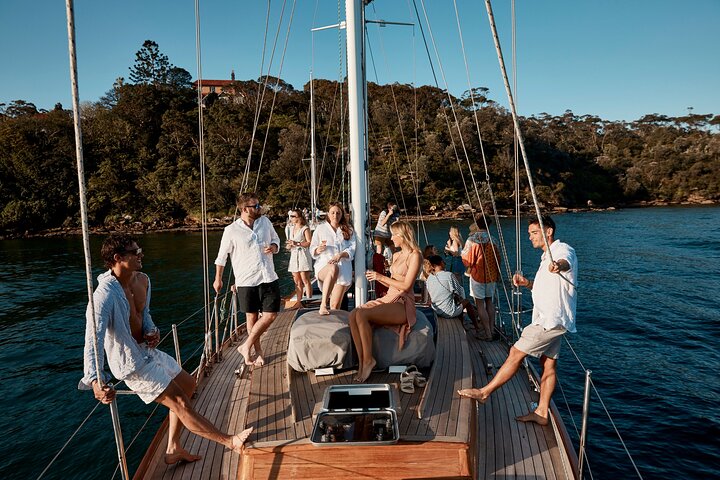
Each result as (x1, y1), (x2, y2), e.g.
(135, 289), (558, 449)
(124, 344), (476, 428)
(310, 203), (355, 315)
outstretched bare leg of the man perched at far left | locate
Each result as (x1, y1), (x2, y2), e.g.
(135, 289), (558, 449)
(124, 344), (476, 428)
(155, 380), (253, 453)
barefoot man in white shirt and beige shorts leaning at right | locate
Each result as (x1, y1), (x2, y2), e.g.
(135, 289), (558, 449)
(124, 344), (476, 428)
(458, 216), (578, 425)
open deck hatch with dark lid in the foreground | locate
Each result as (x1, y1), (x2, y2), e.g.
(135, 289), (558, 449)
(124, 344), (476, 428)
(310, 384), (400, 447)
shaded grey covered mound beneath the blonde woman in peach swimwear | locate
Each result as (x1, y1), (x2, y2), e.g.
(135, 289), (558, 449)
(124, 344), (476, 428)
(373, 309), (435, 368)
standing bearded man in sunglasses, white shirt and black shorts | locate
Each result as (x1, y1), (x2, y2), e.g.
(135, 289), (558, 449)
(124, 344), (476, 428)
(213, 192), (280, 367)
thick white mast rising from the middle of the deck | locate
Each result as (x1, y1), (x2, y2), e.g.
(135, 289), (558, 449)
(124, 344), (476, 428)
(345, 0), (368, 305)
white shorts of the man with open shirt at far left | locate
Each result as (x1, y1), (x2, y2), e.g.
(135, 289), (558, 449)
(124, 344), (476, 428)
(125, 345), (182, 403)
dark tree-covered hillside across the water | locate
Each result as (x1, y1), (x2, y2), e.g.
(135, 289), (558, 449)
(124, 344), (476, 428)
(0, 41), (720, 235)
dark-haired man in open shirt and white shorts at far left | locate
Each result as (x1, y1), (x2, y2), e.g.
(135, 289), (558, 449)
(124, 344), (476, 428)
(78, 234), (252, 464)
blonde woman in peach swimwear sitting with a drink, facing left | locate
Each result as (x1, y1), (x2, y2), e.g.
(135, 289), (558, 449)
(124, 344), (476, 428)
(350, 222), (423, 382)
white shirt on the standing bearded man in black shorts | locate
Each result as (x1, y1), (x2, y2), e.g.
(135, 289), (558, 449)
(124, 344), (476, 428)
(215, 216), (280, 287)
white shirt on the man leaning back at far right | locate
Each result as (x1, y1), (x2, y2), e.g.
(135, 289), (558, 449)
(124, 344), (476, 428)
(532, 240), (578, 333)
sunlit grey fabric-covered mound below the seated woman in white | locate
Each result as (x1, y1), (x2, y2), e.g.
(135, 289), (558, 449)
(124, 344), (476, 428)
(287, 310), (354, 372)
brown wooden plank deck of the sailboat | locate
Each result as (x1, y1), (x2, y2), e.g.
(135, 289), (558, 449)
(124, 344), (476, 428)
(136, 311), (572, 479)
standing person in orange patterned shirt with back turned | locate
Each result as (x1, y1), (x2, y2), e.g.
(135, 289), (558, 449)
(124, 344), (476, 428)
(462, 215), (500, 340)
